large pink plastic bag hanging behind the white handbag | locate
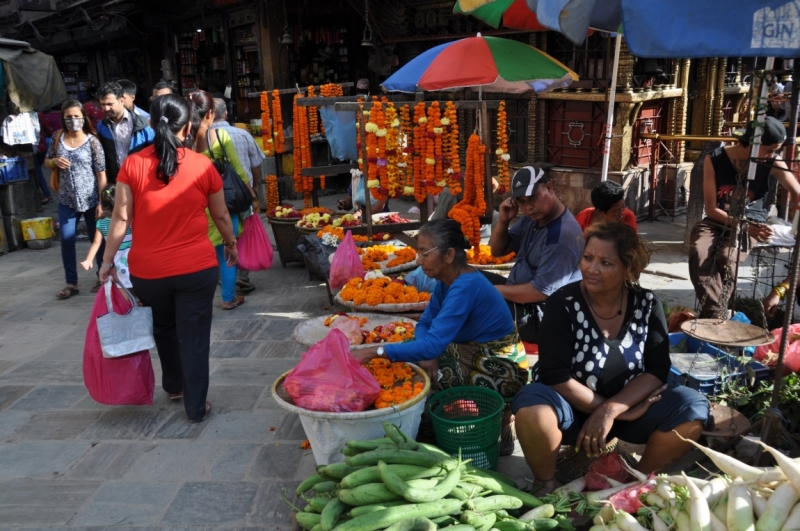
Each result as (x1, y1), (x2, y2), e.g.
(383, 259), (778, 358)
(83, 286), (156, 406)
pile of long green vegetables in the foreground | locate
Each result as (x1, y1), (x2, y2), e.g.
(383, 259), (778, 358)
(284, 423), (574, 531)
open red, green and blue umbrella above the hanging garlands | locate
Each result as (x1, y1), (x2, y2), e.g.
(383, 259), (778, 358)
(382, 33), (578, 94)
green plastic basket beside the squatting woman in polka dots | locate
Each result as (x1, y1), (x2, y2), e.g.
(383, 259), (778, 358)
(428, 385), (505, 469)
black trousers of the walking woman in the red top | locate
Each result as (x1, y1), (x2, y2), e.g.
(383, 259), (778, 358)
(131, 266), (219, 420)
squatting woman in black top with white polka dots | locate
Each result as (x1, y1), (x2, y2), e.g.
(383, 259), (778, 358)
(512, 222), (709, 494)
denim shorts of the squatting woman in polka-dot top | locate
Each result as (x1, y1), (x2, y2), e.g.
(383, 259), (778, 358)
(511, 383), (710, 444)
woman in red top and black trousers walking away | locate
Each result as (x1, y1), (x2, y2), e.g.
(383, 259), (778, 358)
(100, 95), (238, 422)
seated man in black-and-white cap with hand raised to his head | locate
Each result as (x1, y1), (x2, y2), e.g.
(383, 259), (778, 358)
(486, 166), (583, 343)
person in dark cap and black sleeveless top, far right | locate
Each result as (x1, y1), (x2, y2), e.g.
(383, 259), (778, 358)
(689, 116), (800, 318)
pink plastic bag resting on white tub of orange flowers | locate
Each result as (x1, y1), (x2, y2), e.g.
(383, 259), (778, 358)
(283, 329), (381, 412)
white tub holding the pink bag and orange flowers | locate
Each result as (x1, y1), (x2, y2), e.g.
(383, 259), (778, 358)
(272, 363), (432, 465)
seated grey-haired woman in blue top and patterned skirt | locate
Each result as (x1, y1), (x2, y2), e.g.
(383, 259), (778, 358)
(353, 219), (528, 454)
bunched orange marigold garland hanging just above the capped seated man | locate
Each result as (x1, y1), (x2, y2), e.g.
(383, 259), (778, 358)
(448, 133), (486, 263)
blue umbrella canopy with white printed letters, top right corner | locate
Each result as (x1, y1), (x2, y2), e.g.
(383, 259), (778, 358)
(526, 0), (800, 58)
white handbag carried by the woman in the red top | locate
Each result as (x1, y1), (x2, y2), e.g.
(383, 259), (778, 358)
(97, 279), (156, 358)
